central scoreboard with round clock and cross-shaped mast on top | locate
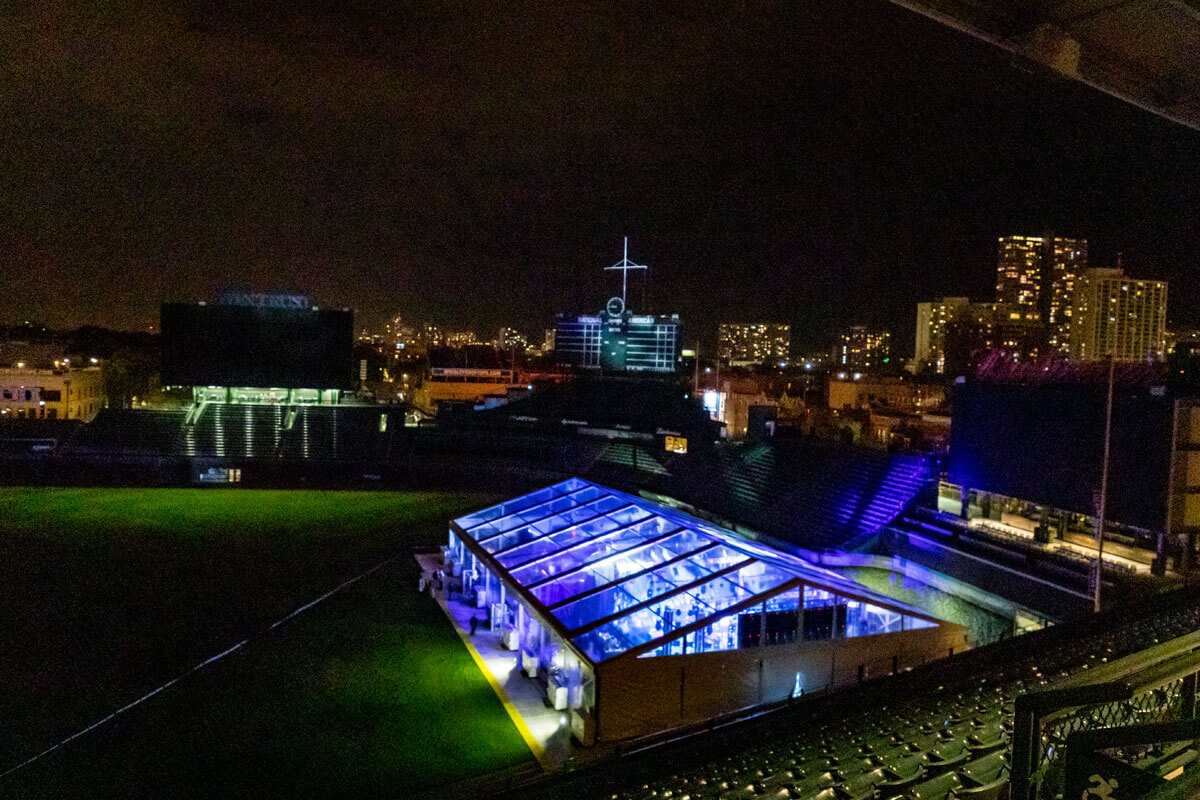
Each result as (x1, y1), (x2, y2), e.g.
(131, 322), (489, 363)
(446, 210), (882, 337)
(554, 243), (682, 374)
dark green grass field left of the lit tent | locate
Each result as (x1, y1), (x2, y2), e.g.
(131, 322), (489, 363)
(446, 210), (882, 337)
(0, 489), (530, 796)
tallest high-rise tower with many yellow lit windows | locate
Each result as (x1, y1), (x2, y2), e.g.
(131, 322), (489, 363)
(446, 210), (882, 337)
(996, 234), (1087, 354)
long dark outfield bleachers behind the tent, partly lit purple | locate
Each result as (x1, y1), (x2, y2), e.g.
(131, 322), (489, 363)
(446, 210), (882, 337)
(0, 379), (1174, 620)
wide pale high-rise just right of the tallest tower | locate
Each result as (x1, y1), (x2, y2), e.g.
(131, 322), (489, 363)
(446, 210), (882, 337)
(1072, 267), (1166, 361)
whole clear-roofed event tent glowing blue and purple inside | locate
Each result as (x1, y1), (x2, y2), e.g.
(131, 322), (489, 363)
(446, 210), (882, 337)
(445, 479), (966, 744)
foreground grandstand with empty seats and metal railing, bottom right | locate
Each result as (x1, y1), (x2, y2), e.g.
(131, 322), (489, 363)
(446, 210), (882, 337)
(508, 590), (1200, 800)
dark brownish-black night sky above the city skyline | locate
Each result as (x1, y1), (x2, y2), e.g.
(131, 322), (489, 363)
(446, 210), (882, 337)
(0, 0), (1200, 349)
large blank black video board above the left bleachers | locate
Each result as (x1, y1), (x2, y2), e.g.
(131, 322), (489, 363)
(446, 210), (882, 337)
(162, 303), (354, 389)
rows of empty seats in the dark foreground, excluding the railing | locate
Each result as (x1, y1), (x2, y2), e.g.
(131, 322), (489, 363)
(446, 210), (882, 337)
(522, 590), (1200, 800)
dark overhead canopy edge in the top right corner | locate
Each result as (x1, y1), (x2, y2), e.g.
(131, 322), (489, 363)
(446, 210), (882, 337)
(892, 0), (1200, 130)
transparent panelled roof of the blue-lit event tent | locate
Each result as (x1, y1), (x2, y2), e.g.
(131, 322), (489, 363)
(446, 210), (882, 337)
(451, 479), (946, 664)
